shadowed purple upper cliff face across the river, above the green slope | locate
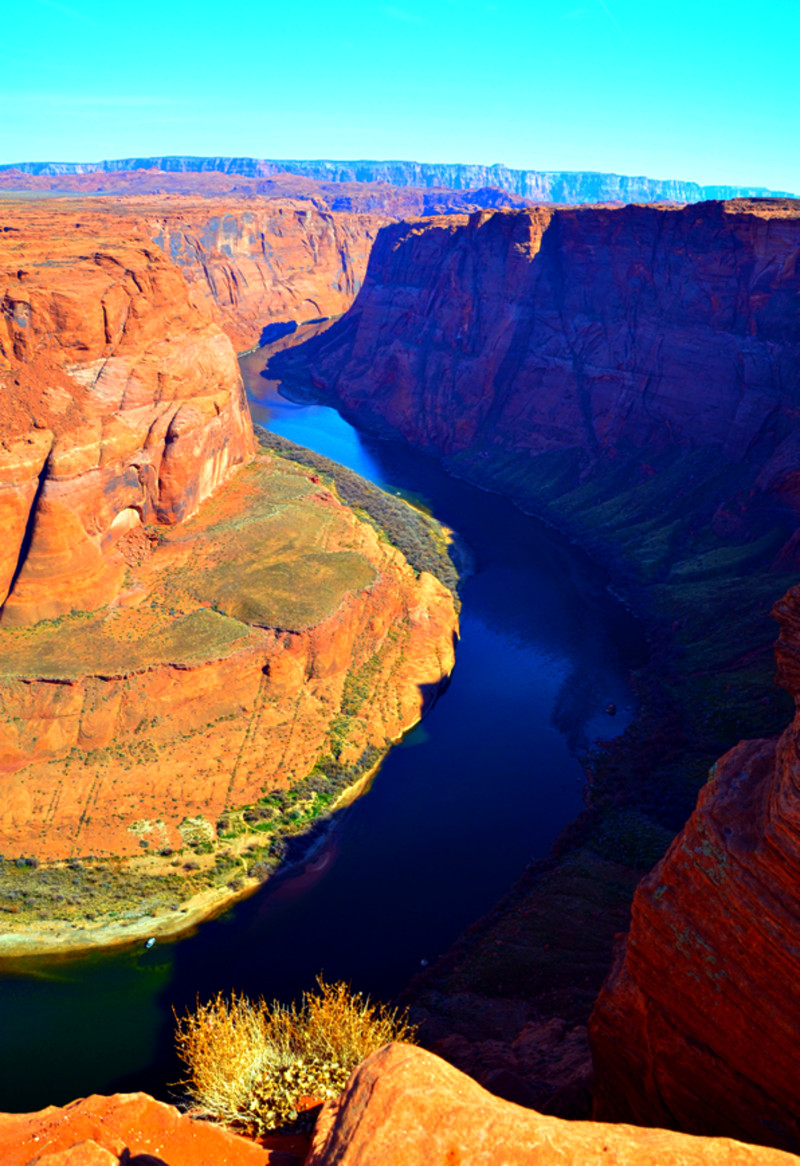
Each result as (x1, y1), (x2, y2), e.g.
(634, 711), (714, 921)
(273, 203), (800, 524)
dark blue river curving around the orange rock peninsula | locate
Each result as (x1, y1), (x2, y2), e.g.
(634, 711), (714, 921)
(0, 353), (643, 1110)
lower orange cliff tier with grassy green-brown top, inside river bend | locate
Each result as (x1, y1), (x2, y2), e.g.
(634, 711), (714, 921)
(0, 457), (456, 865)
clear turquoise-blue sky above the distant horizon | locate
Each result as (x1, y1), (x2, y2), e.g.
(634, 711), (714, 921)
(0, 0), (800, 192)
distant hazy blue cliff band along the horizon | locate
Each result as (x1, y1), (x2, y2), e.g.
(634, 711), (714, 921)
(0, 155), (792, 204)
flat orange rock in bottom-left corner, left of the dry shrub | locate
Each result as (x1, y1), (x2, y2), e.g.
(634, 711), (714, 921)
(0, 1094), (291, 1166)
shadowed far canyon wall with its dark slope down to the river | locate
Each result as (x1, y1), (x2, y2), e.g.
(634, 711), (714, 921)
(269, 202), (800, 1119)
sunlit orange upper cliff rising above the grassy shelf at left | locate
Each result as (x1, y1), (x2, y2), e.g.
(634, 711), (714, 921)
(0, 206), (253, 626)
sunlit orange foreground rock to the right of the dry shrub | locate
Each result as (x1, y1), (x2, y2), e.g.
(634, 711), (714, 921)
(306, 1045), (798, 1166)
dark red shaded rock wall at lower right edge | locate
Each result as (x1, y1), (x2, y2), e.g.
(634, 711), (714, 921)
(591, 578), (800, 1151)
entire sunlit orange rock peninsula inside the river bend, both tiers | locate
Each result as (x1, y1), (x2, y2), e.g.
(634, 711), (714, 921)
(0, 202), (457, 951)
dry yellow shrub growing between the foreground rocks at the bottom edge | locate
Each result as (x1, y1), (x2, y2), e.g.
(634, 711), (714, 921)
(176, 977), (415, 1133)
